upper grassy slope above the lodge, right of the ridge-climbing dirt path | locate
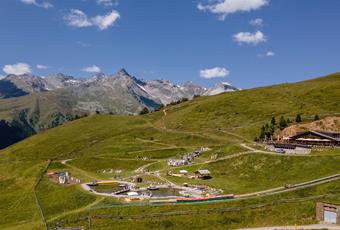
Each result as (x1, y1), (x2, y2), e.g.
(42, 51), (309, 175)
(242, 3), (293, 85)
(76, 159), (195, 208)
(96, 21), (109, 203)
(155, 73), (340, 140)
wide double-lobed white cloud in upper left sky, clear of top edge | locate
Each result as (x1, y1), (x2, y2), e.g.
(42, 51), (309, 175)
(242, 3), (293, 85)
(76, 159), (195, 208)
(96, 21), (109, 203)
(64, 9), (120, 30)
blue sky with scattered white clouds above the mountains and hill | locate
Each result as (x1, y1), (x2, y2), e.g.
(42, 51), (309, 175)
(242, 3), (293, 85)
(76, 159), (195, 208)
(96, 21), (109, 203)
(0, 0), (340, 88)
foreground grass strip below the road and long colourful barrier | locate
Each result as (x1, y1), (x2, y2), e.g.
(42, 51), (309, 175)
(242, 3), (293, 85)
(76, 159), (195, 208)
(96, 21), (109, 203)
(51, 181), (340, 230)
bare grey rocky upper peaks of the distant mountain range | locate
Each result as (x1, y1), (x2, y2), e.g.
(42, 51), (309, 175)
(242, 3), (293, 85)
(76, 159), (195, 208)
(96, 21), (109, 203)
(0, 69), (239, 108)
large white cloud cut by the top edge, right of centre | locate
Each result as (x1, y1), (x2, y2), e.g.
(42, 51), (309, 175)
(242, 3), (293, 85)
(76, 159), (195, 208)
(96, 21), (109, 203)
(197, 0), (269, 20)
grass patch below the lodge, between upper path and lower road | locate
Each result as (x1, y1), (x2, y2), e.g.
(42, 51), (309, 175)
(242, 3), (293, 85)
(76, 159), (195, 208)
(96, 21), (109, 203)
(164, 154), (340, 194)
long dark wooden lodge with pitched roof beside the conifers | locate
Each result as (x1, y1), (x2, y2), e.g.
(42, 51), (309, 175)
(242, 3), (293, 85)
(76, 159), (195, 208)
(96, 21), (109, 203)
(284, 131), (340, 147)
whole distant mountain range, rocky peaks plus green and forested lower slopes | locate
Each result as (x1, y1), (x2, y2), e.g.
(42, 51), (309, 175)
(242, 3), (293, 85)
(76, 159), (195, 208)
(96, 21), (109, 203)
(0, 69), (239, 147)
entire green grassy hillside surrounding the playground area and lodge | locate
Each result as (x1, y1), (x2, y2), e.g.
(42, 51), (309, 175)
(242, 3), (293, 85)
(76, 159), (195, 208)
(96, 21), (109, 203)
(0, 74), (340, 229)
